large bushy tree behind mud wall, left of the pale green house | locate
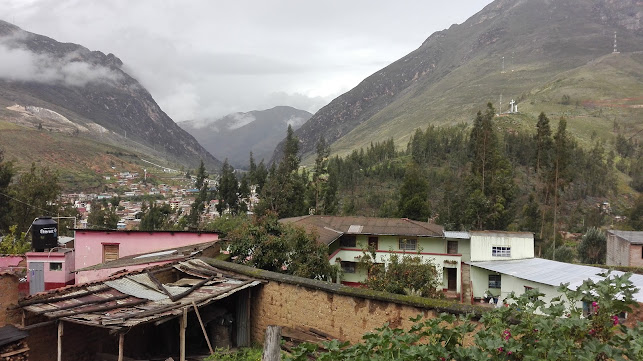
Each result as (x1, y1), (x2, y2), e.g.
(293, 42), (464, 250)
(228, 213), (337, 280)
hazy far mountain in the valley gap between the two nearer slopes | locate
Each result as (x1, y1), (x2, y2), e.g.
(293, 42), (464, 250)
(178, 106), (312, 168)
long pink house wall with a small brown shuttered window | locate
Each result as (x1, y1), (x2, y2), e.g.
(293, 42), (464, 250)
(74, 229), (219, 283)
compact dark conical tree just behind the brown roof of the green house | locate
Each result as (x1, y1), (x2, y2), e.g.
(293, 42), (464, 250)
(398, 165), (431, 221)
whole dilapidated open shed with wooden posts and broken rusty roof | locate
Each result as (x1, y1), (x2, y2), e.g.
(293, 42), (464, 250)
(19, 260), (261, 361)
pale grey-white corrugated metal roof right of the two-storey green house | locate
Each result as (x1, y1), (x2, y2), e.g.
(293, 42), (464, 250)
(465, 258), (643, 302)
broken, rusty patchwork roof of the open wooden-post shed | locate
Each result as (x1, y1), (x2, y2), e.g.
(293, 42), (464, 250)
(19, 259), (261, 329)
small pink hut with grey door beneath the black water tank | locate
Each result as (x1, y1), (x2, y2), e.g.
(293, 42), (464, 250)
(25, 247), (75, 295)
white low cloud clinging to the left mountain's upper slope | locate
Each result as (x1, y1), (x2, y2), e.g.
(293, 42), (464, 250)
(0, 37), (121, 87)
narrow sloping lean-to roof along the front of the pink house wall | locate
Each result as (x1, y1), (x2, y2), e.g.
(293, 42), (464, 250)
(75, 241), (220, 283)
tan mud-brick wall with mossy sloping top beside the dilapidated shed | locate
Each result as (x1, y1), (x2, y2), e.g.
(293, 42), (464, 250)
(203, 259), (485, 343)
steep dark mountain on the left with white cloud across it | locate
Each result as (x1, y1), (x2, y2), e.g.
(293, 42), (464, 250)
(0, 20), (221, 169)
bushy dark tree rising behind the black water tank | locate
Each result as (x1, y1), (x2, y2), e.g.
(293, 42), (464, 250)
(10, 163), (61, 231)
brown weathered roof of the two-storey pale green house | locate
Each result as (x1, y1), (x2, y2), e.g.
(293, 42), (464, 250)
(280, 216), (444, 244)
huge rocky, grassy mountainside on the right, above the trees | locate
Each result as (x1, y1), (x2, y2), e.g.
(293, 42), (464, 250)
(272, 0), (643, 161)
